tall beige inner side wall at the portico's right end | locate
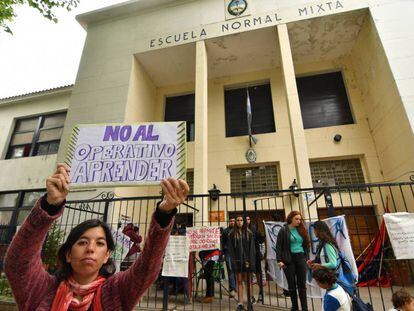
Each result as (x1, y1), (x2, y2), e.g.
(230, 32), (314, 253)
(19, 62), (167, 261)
(351, 14), (414, 181)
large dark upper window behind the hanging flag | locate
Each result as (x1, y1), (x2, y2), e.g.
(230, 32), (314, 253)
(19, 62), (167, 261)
(224, 84), (276, 137)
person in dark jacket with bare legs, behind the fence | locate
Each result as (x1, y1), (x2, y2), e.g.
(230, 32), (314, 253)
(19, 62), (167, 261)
(228, 216), (256, 310)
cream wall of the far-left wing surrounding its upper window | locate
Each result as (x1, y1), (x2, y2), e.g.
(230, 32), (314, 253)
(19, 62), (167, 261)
(0, 91), (70, 191)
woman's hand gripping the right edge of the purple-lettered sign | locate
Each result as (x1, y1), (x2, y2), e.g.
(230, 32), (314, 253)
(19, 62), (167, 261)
(160, 177), (190, 213)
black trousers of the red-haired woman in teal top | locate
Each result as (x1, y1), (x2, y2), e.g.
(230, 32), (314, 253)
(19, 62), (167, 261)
(284, 253), (308, 311)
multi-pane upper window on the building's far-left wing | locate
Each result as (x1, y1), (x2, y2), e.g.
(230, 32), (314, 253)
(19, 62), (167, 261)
(6, 112), (66, 159)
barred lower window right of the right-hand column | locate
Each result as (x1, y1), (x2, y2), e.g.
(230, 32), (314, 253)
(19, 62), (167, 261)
(310, 159), (365, 186)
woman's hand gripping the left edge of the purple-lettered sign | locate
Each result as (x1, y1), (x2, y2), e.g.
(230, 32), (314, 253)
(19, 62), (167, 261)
(46, 163), (70, 206)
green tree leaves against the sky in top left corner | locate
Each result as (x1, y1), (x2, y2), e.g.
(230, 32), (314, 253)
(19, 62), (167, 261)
(0, 0), (80, 34)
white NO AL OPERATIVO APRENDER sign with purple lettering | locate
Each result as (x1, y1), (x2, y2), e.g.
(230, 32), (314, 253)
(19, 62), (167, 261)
(65, 122), (187, 188)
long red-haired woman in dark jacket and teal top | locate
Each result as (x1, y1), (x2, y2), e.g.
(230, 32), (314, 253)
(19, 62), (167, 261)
(276, 211), (310, 311)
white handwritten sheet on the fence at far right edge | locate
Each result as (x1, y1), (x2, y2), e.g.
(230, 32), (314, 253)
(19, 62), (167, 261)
(384, 213), (414, 259)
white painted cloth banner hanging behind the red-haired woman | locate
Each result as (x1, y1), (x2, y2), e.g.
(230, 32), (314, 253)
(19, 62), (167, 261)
(264, 215), (358, 298)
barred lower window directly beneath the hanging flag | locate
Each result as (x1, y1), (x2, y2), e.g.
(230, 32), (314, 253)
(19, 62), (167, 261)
(230, 164), (279, 193)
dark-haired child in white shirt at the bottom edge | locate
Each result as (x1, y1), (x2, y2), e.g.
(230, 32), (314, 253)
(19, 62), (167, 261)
(312, 267), (351, 311)
